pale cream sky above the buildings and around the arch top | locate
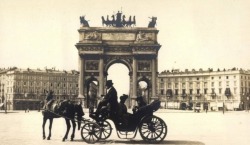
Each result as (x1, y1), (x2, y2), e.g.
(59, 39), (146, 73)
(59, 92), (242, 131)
(0, 0), (250, 95)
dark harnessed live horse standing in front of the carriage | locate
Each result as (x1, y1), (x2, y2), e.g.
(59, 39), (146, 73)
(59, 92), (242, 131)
(42, 97), (84, 141)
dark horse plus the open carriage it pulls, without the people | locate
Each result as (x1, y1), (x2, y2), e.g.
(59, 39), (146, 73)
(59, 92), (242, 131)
(43, 90), (167, 143)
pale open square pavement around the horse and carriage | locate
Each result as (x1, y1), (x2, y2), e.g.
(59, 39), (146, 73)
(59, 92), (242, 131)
(0, 110), (250, 145)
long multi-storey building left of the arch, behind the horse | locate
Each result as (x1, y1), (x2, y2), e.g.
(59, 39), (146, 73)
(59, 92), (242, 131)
(0, 67), (79, 110)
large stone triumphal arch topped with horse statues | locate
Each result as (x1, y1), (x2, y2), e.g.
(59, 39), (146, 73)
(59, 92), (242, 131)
(75, 12), (161, 106)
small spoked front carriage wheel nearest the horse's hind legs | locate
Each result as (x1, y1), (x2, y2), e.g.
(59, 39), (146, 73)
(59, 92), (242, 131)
(81, 122), (101, 143)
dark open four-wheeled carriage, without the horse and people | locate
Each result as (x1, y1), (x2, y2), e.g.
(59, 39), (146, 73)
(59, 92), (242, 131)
(81, 100), (167, 143)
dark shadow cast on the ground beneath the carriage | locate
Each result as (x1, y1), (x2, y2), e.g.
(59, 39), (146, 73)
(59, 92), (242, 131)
(75, 139), (205, 145)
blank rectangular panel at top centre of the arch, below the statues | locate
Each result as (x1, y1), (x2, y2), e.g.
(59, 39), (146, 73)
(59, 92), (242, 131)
(102, 33), (135, 40)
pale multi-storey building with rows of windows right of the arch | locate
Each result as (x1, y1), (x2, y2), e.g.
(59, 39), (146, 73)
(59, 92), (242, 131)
(158, 68), (250, 110)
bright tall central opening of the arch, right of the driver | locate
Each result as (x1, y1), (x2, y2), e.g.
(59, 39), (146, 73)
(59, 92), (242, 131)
(107, 63), (130, 106)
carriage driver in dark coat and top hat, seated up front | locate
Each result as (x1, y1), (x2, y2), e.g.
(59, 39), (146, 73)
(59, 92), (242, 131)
(96, 80), (118, 114)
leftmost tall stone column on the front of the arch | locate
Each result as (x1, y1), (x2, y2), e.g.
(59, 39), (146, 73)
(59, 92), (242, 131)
(78, 56), (85, 98)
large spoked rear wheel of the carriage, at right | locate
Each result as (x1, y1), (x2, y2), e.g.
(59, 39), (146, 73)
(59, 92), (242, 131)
(139, 116), (168, 143)
